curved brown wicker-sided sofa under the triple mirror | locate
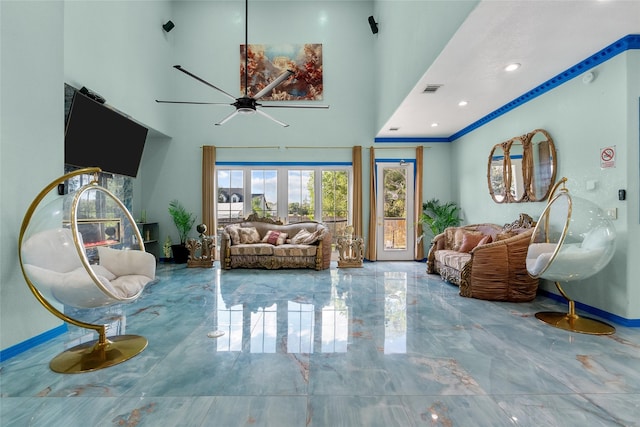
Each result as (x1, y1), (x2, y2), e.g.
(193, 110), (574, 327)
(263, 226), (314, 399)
(427, 214), (538, 302)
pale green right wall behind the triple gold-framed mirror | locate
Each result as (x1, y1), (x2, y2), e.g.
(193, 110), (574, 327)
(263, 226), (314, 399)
(453, 51), (640, 318)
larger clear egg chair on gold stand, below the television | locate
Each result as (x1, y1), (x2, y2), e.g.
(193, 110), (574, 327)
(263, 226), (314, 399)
(18, 168), (156, 373)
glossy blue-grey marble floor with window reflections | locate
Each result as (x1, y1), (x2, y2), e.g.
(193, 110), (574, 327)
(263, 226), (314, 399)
(0, 262), (640, 427)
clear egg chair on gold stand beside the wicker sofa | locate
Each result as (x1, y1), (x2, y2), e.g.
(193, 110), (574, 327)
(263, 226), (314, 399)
(527, 178), (616, 335)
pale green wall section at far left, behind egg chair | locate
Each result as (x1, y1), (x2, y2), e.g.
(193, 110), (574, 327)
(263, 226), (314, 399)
(0, 1), (64, 349)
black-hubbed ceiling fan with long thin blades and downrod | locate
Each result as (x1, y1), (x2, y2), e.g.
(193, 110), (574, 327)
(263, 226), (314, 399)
(156, 0), (329, 127)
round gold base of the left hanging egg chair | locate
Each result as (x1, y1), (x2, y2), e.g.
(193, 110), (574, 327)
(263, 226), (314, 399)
(49, 335), (147, 374)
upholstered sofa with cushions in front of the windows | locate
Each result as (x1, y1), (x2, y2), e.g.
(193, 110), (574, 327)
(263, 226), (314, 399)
(220, 215), (331, 270)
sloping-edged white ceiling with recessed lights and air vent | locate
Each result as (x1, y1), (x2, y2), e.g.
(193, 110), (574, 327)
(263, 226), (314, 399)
(377, 0), (640, 139)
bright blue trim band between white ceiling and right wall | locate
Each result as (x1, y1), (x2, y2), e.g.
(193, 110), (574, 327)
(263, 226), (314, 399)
(374, 34), (640, 143)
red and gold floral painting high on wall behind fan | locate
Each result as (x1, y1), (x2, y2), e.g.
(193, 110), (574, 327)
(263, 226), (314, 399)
(240, 43), (323, 101)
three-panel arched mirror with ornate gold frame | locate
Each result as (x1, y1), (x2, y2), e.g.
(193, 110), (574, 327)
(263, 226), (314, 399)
(487, 129), (556, 203)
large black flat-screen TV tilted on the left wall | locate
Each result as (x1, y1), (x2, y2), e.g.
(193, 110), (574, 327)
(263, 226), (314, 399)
(64, 92), (148, 178)
